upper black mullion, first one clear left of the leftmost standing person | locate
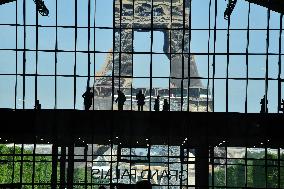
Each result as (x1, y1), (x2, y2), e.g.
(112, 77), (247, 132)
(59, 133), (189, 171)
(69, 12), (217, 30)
(73, 0), (78, 109)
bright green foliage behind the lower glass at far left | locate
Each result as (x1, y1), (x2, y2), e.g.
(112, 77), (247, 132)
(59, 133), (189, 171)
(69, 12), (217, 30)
(0, 145), (52, 188)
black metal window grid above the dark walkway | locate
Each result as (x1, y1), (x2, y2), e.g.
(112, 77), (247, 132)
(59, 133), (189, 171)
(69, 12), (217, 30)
(0, 0), (283, 113)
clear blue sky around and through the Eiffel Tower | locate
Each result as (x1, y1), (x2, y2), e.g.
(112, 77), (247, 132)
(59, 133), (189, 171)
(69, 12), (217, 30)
(0, 0), (284, 112)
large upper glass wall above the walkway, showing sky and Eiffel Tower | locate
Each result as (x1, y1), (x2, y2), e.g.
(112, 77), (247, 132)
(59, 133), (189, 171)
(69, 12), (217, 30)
(0, 0), (283, 113)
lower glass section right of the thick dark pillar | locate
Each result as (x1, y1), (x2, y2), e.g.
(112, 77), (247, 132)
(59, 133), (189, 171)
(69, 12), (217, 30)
(209, 144), (284, 188)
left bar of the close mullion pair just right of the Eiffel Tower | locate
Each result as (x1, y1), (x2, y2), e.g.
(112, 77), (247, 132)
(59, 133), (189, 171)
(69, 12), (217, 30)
(206, 0), (212, 112)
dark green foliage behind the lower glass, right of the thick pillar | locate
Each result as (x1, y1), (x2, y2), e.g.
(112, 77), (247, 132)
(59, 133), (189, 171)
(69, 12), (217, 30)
(214, 153), (284, 188)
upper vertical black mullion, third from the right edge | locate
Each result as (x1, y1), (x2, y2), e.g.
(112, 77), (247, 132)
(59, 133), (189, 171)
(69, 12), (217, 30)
(245, 3), (250, 113)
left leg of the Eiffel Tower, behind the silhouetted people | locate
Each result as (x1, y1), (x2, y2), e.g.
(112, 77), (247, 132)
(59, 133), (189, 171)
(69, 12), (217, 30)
(91, 29), (133, 110)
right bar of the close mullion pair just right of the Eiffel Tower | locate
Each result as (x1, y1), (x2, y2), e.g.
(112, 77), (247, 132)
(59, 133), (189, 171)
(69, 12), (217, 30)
(212, 0), (218, 112)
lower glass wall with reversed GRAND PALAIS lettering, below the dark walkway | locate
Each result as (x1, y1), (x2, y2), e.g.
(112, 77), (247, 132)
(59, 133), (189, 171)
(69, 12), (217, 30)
(0, 142), (284, 188)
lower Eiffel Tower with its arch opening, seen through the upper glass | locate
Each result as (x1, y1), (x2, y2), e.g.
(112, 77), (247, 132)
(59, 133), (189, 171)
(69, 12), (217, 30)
(94, 0), (209, 109)
